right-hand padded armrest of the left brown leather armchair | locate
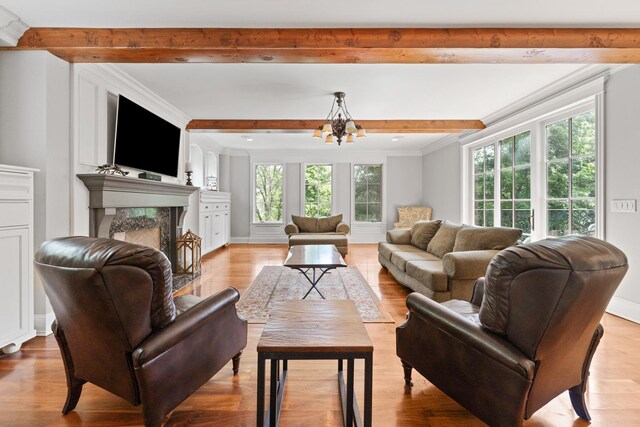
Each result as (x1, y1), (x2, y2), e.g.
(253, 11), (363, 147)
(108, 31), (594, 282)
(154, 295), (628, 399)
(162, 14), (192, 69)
(133, 288), (240, 368)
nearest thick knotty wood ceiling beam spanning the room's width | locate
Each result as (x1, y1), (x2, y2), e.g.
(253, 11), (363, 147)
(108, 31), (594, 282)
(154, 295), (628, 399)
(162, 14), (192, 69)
(11, 28), (640, 63)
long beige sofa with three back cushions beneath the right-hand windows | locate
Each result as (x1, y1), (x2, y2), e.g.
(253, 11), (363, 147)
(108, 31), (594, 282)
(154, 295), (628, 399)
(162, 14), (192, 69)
(378, 220), (522, 302)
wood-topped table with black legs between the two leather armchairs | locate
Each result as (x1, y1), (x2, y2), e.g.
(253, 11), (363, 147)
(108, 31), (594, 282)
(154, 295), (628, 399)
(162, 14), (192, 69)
(257, 300), (373, 427)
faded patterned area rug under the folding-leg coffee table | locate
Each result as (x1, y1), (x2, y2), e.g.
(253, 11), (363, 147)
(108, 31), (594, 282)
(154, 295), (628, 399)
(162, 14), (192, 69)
(236, 266), (393, 323)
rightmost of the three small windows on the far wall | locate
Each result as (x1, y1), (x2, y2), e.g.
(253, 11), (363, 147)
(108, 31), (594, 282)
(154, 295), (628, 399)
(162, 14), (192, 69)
(353, 165), (382, 222)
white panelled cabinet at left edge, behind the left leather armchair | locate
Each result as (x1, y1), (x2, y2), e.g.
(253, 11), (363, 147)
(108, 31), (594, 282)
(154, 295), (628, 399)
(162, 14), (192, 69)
(0, 165), (36, 353)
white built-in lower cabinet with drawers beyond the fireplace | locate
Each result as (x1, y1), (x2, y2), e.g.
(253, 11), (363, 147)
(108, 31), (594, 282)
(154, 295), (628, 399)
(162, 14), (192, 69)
(199, 190), (231, 254)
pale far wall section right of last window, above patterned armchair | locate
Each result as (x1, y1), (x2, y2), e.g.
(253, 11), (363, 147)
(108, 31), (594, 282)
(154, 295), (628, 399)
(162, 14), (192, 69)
(387, 156), (423, 229)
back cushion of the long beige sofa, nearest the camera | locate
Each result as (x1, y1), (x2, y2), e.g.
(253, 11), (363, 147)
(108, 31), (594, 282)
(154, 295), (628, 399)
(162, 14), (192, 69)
(453, 226), (522, 252)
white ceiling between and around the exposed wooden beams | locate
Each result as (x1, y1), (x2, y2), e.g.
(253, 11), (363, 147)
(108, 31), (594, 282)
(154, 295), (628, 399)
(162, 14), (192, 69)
(0, 0), (640, 150)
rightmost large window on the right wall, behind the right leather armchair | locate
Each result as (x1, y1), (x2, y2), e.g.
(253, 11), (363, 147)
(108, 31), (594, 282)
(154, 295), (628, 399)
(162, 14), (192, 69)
(545, 111), (597, 236)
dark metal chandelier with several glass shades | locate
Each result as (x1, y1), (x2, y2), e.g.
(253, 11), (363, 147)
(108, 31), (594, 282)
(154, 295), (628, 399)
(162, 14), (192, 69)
(313, 92), (367, 145)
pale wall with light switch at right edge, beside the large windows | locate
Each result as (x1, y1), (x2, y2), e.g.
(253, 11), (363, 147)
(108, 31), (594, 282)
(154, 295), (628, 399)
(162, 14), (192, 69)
(605, 65), (640, 322)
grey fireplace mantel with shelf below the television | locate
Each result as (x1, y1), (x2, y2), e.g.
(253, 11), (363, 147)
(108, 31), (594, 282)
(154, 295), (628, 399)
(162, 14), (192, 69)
(77, 174), (198, 265)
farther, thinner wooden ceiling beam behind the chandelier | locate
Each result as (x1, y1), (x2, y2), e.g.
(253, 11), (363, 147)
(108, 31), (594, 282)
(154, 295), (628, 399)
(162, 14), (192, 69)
(187, 120), (485, 133)
